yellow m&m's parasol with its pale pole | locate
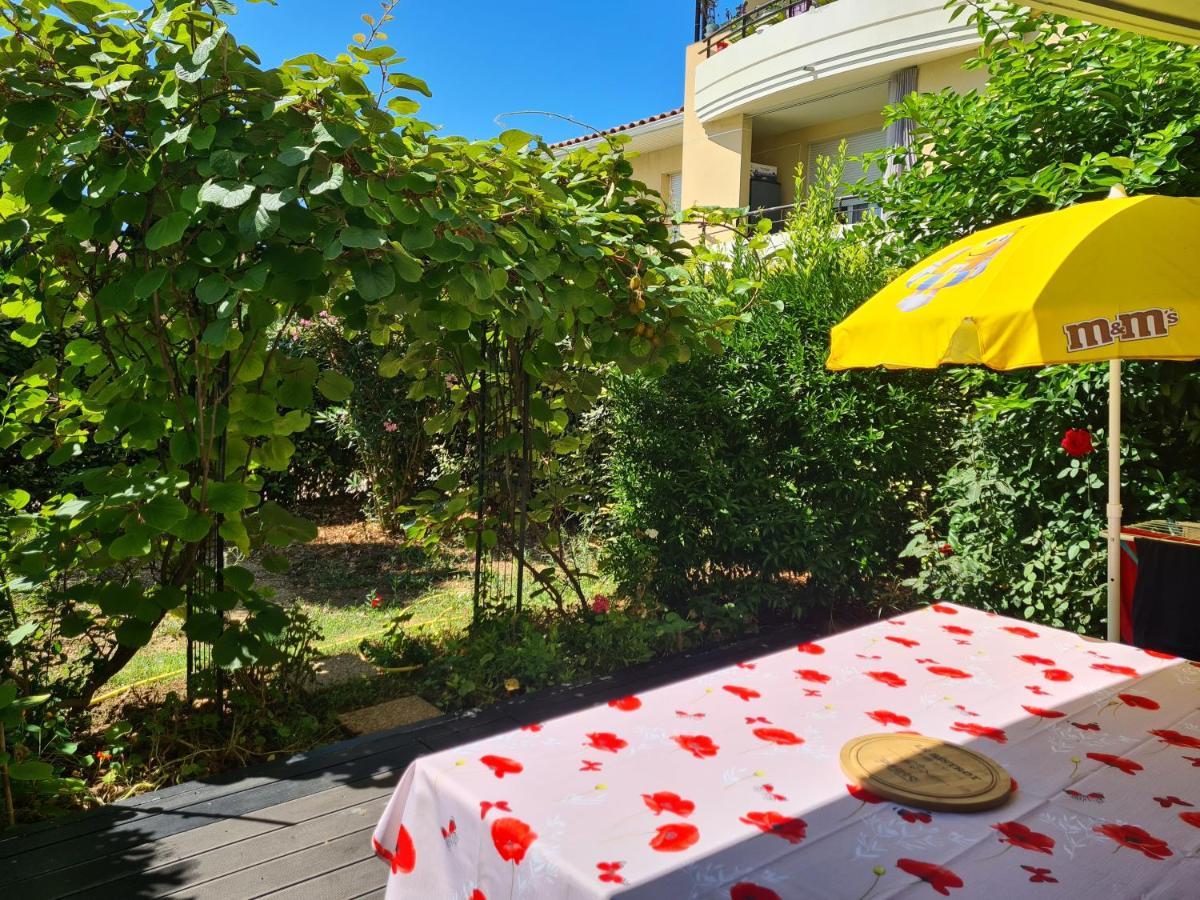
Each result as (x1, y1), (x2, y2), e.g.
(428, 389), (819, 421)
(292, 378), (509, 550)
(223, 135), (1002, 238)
(827, 188), (1200, 641)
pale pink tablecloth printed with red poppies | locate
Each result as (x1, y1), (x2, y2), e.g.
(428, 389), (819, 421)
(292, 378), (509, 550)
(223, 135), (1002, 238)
(374, 605), (1200, 900)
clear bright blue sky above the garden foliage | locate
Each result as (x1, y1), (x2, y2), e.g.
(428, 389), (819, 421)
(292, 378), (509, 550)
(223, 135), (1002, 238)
(230, 0), (695, 140)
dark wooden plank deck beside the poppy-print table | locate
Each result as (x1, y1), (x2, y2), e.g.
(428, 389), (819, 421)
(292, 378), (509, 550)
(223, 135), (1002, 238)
(0, 629), (808, 900)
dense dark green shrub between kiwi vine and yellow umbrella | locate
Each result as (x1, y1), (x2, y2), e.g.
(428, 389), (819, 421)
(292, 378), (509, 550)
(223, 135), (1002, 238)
(610, 164), (954, 617)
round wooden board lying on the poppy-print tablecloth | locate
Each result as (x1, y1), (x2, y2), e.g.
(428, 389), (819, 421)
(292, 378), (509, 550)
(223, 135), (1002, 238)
(841, 734), (1013, 812)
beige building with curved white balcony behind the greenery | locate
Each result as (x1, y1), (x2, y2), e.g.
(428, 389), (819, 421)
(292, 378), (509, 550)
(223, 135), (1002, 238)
(556, 0), (985, 221)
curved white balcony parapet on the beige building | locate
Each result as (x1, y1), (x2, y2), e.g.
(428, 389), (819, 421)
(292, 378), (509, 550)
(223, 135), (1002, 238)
(695, 0), (979, 122)
